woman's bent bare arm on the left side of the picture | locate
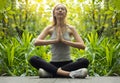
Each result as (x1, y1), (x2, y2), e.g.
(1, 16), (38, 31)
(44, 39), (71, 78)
(34, 26), (58, 46)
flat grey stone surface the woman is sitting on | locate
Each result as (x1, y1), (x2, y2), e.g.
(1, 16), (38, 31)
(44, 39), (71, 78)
(0, 76), (120, 83)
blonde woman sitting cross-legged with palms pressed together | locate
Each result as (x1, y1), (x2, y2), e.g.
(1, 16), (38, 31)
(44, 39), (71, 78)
(30, 4), (89, 78)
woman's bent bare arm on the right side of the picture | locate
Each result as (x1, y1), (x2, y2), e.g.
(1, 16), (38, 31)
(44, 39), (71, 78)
(61, 27), (85, 49)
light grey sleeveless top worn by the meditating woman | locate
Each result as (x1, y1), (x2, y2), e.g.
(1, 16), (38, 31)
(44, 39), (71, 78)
(51, 27), (71, 62)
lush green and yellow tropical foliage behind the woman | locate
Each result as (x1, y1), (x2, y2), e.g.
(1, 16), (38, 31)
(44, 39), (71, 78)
(0, 0), (120, 76)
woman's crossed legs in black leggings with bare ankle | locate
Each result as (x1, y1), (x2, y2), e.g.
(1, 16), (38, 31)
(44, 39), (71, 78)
(29, 56), (89, 77)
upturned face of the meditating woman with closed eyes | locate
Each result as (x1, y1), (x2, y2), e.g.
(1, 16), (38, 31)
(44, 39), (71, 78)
(54, 4), (67, 18)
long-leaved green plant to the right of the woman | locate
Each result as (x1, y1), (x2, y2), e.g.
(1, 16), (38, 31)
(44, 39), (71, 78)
(85, 32), (120, 76)
